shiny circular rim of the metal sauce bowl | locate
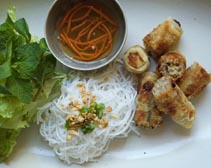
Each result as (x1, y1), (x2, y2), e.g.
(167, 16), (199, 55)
(44, 0), (128, 71)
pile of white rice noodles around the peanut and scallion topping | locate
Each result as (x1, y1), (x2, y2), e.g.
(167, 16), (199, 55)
(37, 61), (136, 164)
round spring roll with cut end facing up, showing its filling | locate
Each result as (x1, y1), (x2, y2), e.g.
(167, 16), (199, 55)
(156, 51), (186, 81)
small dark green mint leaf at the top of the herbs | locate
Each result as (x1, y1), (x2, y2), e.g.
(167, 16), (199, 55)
(15, 18), (31, 43)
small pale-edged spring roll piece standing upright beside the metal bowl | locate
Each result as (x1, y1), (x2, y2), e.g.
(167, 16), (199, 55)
(124, 45), (150, 74)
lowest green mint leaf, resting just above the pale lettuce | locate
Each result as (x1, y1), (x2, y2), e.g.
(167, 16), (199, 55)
(6, 76), (32, 103)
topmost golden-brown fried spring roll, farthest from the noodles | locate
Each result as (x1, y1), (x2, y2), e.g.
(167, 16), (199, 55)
(143, 18), (183, 59)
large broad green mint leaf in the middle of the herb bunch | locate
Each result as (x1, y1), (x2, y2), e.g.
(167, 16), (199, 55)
(12, 43), (43, 79)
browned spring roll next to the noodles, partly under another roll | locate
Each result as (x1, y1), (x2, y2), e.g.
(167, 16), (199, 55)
(134, 72), (163, 128)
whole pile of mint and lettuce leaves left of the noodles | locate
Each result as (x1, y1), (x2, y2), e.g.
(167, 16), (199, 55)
(0, 7), (66, 162)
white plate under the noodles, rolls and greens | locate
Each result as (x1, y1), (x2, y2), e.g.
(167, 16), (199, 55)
(0, 0), (211, 168)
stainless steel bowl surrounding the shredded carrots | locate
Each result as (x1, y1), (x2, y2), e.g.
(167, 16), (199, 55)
(45, 0), (127, 71)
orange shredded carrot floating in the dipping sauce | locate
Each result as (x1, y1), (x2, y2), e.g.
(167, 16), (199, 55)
(59, 3), (118, 61)
